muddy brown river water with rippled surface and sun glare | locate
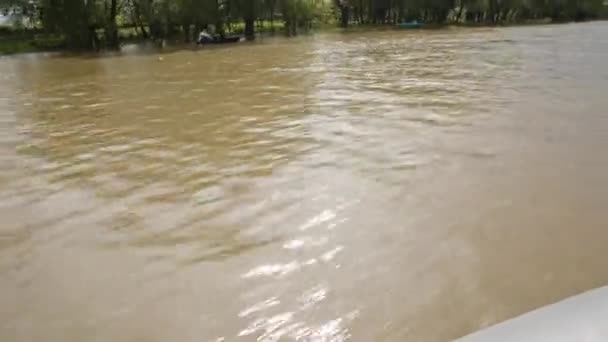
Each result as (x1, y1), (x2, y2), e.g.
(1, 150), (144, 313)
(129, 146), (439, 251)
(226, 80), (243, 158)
(0, 22), (608, 342)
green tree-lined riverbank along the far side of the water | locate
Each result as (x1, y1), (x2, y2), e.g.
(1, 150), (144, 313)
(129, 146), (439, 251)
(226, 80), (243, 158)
(0, 0), (608, 52)
